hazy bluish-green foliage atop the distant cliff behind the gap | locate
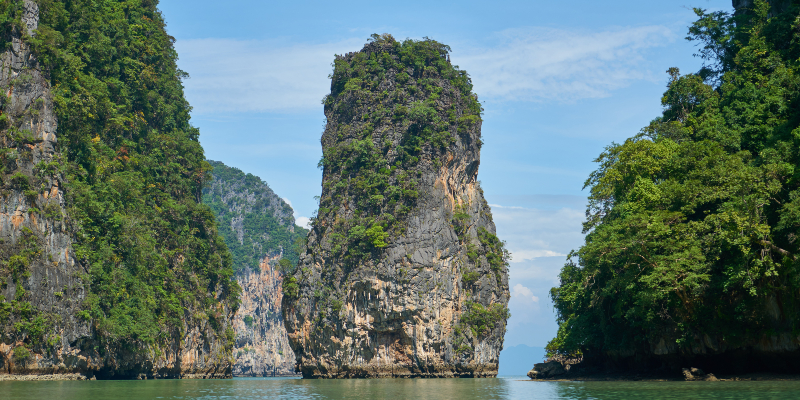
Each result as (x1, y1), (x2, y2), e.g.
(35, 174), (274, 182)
(203, 161), (308, 272)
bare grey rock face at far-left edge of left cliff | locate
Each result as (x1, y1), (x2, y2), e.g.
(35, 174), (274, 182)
(0, 1), (91, 373)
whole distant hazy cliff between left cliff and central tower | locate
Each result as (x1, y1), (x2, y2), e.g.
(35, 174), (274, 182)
(203, 161), (307, 376)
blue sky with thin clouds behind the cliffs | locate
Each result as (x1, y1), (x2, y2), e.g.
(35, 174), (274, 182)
(160, 0), (731, 346)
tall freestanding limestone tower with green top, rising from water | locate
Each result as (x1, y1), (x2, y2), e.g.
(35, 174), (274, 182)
(283, 35), (509, 378)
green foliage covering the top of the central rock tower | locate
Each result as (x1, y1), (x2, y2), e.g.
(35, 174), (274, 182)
(312, 34), (483, 261)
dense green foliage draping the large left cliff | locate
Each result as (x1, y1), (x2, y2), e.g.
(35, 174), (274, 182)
(0, 0), (239, 352)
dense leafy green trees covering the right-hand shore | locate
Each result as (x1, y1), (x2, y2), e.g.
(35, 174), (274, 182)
(548, 0), (800, 355)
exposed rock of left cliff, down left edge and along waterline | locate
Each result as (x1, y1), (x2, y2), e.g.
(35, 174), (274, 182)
(0, 0), (232, 379)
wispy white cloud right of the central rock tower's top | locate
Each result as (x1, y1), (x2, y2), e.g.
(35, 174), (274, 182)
(452, 26), (674, 101)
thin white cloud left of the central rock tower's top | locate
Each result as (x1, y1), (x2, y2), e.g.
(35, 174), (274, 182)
(175, 38), (363, 114)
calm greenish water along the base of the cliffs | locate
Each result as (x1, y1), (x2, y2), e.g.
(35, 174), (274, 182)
(0, 377), (800, 400)
